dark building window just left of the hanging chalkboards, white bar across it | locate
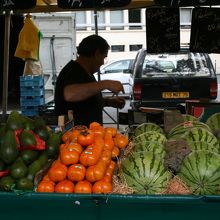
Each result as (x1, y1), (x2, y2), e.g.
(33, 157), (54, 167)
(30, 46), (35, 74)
(128, 9), (141, 30)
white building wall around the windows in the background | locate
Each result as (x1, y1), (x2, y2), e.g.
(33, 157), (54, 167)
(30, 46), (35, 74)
(76, 8), (220, 74)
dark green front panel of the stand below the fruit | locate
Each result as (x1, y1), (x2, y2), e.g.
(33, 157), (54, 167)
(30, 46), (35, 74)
(0, 193), (220, 220)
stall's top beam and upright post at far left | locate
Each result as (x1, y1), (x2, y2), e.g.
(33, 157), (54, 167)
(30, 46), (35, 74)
(0, 0), (154, 117)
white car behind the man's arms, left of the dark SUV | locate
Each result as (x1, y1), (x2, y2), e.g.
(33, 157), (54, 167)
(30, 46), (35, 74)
(94, 59), (134, 97)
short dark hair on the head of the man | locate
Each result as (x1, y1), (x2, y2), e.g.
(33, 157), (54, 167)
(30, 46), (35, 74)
(77, 34), (110, 57)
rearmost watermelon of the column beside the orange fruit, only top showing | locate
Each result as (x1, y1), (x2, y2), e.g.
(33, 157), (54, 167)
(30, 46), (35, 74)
(133, 122), (164, 137)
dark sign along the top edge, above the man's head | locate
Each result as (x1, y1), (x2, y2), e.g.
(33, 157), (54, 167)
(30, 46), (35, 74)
(57, 0), (131, 9)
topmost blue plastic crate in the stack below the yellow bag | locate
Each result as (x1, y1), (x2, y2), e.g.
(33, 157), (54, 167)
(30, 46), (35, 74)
(20, 75), (44, 87)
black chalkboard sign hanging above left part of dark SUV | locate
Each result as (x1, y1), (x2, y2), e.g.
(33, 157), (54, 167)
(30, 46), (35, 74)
(146, 7), (180, 53)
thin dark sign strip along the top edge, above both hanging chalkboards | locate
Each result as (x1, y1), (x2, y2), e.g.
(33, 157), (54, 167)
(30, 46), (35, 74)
(154, 0), (220, 7)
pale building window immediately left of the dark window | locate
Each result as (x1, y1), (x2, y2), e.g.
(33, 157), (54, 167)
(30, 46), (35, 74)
(110, 10), (124, 30)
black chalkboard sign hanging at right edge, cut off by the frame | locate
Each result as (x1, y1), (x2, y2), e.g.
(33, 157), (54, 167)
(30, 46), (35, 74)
(190, 7), (220, 53)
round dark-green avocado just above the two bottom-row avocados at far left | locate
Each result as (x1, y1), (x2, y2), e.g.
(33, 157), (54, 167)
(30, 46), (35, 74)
(10, 161), (28, 179)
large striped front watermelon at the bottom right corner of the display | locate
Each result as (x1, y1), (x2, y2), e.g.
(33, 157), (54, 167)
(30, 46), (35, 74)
(177, 151), (220, 195)
